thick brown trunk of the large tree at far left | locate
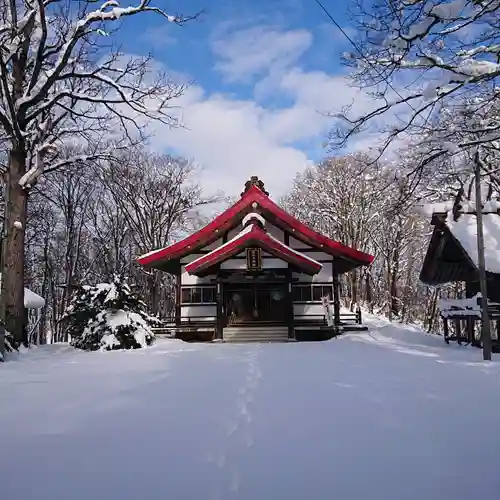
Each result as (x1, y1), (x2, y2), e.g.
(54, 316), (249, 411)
(3, 148), (28, 344)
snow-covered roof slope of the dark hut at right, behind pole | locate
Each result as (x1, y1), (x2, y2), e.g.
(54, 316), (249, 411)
(446, 213), (500, 274)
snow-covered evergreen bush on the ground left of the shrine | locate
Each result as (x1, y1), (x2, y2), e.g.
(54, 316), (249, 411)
(64, 277), (158, 351)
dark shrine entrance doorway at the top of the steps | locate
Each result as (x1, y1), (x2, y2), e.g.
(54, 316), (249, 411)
(224, 283), (286, 325)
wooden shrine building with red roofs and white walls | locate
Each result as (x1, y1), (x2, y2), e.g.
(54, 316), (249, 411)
(138, 177), (373, 341)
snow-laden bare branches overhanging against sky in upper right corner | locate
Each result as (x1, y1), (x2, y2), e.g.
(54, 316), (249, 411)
(331, 0), (500, 183)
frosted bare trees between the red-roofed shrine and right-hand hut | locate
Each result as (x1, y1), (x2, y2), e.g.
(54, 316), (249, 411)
(283, 155), (444, 329)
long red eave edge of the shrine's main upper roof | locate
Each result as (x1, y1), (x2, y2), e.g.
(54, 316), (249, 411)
(137, 186), (374, 266)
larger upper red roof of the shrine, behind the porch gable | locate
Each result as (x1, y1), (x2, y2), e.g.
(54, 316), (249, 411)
(137, 186), (373, 269)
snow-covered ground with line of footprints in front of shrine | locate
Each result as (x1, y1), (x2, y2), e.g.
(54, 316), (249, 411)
(0, 317), (500, 500)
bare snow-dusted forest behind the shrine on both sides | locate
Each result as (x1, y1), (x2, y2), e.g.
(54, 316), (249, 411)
(1, 148), (462, 343)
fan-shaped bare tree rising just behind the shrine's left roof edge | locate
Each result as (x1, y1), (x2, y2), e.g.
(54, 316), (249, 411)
(102, 151), (222, 313)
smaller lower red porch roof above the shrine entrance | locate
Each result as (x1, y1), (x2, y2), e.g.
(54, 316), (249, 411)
(186, 224), (323, 275)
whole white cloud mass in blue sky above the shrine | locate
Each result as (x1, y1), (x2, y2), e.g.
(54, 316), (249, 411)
(143, 28), (380, 197)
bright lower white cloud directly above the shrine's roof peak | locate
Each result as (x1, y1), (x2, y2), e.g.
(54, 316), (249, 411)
(148, 87), (308, 196)
